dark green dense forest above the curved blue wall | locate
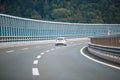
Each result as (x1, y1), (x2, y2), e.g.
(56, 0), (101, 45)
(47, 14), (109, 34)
(0, 0), (120, 24)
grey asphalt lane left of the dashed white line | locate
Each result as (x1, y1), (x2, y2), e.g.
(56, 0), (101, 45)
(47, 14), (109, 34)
(0, 45), (54, 80)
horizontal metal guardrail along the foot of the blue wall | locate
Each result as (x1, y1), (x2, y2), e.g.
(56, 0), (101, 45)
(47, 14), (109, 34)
(0, 35), (87, 42)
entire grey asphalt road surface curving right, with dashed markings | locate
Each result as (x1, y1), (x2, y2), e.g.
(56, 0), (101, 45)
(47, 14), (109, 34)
(0, 41), (120, 80)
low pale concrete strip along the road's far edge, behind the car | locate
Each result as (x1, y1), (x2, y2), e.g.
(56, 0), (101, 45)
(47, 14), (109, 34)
(0, 38), (89, 48)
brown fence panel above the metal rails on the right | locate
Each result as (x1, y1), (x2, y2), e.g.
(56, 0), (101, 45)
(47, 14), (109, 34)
(90, 34), (120, 47)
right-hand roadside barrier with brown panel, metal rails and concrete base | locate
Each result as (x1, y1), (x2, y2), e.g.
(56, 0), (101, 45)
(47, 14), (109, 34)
(88, 35), (120, 63)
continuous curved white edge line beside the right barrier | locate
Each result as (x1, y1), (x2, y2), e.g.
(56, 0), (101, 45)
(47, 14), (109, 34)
(80, 47), (120, 70)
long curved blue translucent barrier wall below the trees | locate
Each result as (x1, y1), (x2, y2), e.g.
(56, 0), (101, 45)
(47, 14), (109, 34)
(0, 14), (120, 42)
